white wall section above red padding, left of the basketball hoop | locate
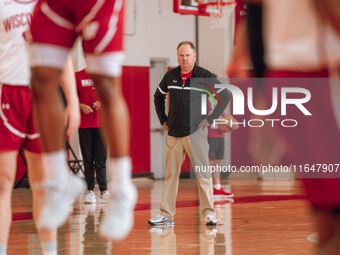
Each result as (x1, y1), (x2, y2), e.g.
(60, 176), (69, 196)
(124, 0), (195, 66)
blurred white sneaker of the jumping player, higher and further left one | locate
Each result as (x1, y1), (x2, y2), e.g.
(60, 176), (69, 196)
(38, 174), (86, 229)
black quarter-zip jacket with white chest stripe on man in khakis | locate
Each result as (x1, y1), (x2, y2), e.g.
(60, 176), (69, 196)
(154, 64), (230, 137)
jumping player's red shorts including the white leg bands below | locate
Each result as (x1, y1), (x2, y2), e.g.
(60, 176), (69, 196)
(30, 0), (125, 77)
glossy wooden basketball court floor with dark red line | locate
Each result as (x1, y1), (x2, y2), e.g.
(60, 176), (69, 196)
(8, 178), (314, 255)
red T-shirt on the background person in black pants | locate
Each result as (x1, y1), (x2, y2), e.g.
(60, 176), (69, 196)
(76, 70), (100, 128)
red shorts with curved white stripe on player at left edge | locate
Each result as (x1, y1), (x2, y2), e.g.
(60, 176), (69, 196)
(0, 84), (41, 153)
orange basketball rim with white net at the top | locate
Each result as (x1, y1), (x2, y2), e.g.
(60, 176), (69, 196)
(198, 1), (236, 28)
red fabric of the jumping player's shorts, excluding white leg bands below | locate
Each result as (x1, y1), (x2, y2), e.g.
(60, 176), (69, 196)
(31, 0), (124, 53)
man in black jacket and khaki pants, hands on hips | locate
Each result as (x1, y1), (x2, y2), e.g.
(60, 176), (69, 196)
(149, 41), (230, 225)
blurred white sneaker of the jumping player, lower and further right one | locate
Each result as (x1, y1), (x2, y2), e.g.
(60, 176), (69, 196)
(100, 183), (138, 240)
